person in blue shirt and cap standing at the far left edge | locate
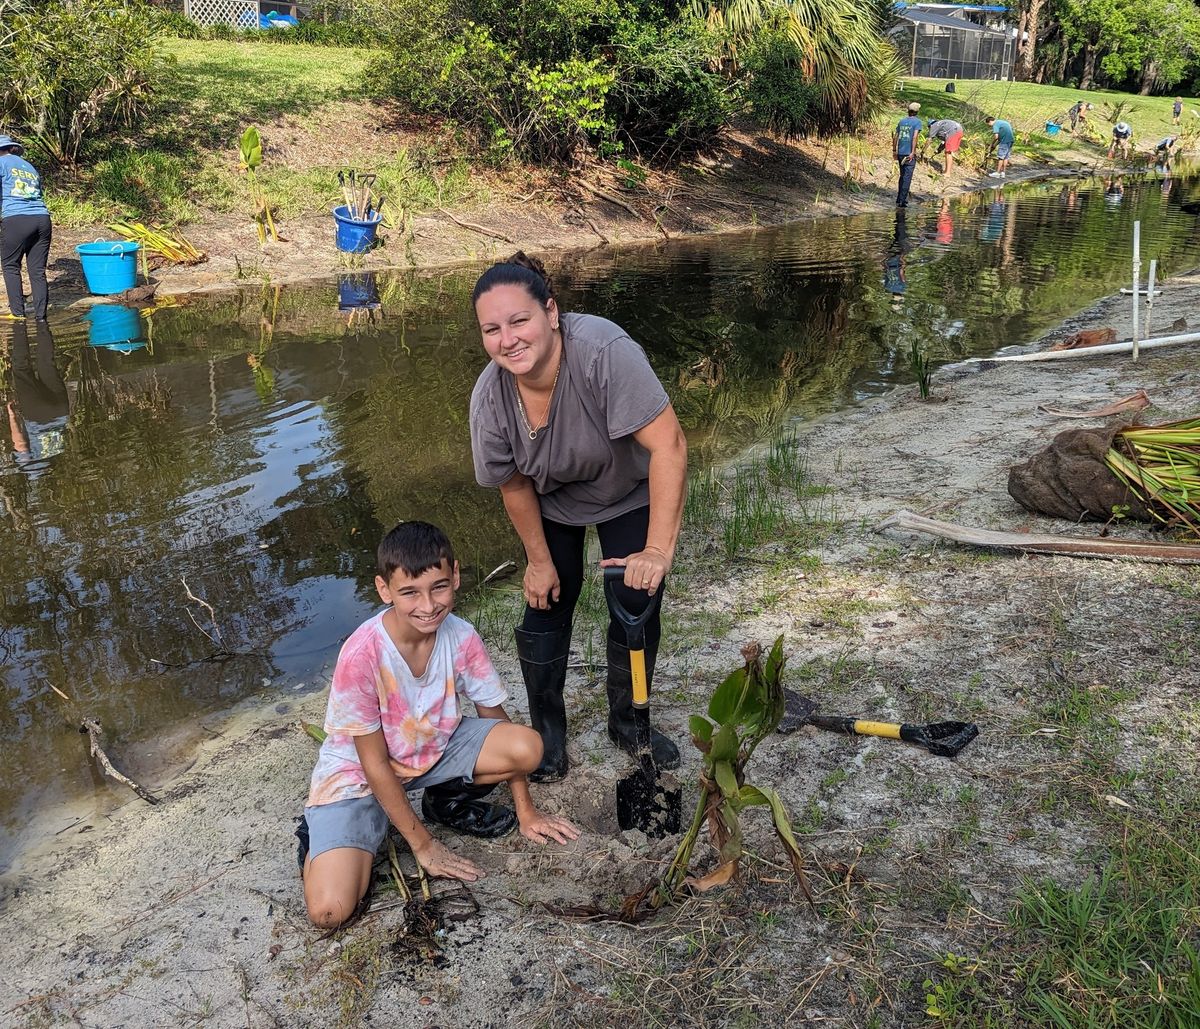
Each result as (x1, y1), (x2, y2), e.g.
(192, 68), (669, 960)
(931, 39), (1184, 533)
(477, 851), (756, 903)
(0, 136), (50, 321)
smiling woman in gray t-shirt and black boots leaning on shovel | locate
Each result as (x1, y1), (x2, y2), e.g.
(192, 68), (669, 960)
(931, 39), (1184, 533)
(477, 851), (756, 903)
(470, 253), (688, 782)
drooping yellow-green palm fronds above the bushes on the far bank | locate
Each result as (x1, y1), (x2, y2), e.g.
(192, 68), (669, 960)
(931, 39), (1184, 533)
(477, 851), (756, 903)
(689, 0), (900, 134)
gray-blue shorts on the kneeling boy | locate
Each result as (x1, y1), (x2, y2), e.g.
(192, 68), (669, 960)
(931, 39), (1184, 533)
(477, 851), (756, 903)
(304, 717), (502, 860)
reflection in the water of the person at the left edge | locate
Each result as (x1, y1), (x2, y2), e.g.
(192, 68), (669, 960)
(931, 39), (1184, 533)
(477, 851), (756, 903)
(6, 321), (71, 475)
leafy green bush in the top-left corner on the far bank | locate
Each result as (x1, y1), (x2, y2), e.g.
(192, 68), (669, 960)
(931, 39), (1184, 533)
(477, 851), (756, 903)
(0, 0), (172, 164)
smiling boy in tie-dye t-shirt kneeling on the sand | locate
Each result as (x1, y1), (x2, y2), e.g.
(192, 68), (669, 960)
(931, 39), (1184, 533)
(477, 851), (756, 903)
(298, 522), (580, 928)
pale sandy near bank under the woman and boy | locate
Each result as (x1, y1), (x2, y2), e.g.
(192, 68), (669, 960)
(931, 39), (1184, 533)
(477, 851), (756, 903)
(0, 273), (1200, 1027)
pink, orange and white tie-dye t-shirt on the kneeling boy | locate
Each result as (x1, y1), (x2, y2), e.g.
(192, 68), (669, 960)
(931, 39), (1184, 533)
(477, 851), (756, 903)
(308, 609), (508, 807)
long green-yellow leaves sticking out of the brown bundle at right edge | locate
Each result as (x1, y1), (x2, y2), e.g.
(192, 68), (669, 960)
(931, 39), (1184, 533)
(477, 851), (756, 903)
(1105, 419), (1200, 538)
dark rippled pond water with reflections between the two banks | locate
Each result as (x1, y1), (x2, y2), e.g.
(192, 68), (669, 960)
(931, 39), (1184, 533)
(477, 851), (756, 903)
(0, 172), (1200, 866)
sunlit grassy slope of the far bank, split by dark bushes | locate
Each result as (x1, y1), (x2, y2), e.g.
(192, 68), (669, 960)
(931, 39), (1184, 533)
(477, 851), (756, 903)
(42, 40), (1200, 225)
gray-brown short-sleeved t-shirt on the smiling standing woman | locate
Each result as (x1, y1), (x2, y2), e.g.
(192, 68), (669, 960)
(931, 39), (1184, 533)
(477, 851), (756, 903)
(470, 314), (670, 525)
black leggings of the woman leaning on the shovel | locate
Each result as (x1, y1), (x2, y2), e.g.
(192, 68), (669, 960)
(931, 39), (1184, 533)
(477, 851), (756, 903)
(521, 507), (661, 652)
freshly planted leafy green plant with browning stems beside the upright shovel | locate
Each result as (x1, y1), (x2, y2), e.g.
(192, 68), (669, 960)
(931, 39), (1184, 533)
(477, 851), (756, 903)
(648, 637), (812, 908)
